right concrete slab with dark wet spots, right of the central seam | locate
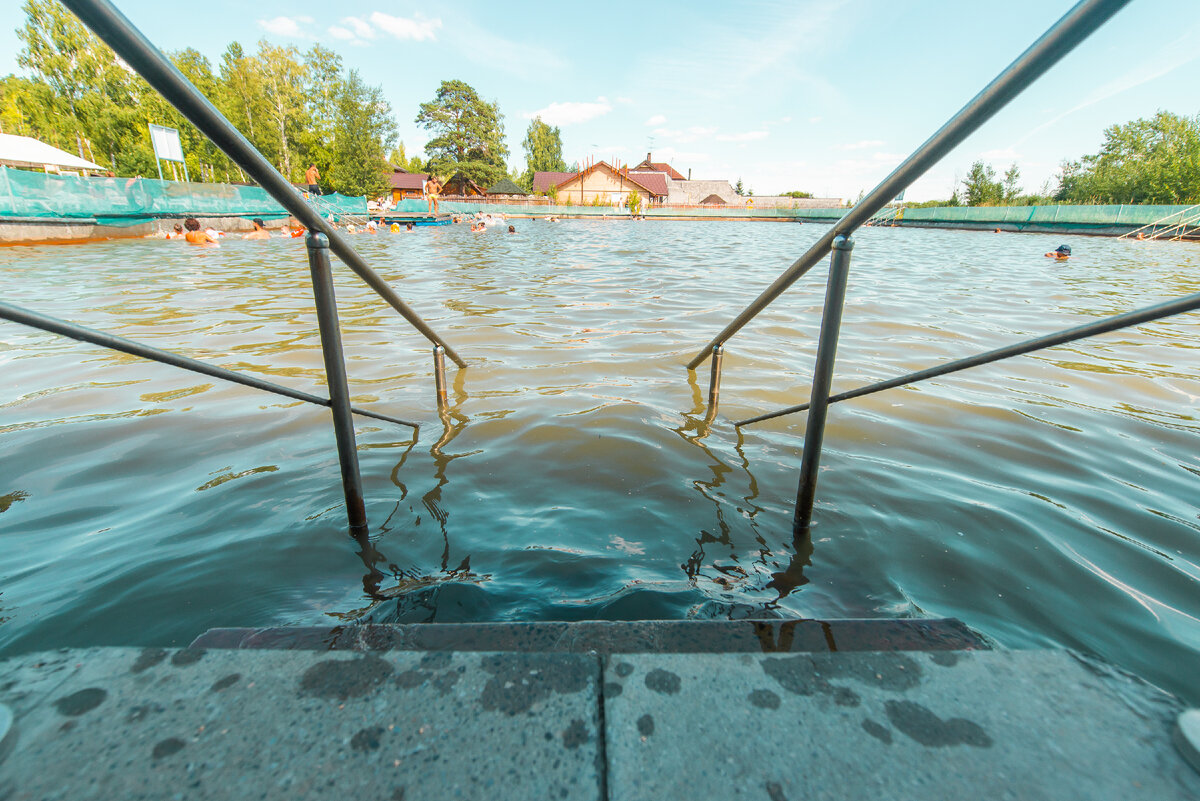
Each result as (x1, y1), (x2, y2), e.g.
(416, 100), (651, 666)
(605, 651), (1200, 801)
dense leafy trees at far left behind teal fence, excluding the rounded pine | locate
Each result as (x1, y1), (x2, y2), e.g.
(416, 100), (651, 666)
(0, 0), (396, 194)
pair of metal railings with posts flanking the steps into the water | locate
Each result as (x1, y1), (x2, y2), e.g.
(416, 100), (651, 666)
(0, 0), (1200, 538)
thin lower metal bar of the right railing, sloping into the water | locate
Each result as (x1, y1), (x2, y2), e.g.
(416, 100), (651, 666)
(733, 293), (1200, 427)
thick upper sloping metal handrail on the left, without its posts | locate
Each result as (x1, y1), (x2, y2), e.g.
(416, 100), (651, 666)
(64, 0), (467, 367)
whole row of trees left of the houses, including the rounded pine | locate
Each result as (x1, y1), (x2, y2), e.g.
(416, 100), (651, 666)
(0, 0), (566, 195)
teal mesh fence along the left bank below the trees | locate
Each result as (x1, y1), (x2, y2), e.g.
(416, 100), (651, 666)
(0, 168), (367, 225)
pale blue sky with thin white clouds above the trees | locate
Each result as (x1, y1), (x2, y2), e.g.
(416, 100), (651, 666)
(0, 0), (1200, 200)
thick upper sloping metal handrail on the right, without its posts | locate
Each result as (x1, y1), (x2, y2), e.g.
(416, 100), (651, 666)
(686, 0), (1129, 369)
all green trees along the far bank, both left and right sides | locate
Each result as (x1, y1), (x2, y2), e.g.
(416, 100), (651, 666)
(0, 0), (1200, 206)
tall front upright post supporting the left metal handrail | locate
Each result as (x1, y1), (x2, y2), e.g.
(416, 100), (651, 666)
(305, 231), (368, 536)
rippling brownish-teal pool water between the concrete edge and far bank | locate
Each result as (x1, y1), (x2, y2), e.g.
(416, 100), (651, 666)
(0, 221), (1200, 700)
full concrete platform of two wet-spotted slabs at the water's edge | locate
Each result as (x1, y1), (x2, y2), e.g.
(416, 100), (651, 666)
(0, 628), (1200, 801)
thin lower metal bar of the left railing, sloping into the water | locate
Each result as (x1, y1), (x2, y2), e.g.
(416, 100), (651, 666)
(0, 303), (420, 429)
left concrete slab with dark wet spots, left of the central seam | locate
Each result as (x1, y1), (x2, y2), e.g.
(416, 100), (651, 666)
(0, 649), (602, 801)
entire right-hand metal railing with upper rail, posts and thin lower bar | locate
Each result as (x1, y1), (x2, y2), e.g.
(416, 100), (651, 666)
(688, 0), (1142, 537)
